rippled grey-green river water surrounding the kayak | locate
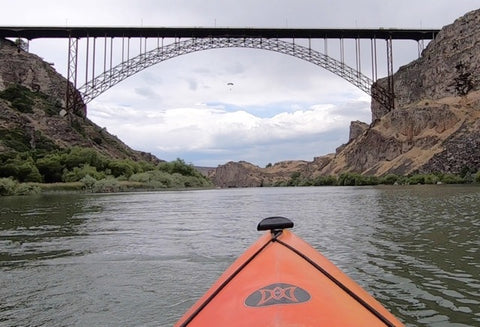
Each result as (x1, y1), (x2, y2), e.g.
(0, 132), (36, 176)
(0, 185), (480, 326)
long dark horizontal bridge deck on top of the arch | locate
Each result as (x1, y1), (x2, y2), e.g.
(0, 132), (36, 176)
(0, 26), (439, 41)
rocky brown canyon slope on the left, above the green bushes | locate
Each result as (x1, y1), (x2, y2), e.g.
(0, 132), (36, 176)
(0, 39), (158, 161)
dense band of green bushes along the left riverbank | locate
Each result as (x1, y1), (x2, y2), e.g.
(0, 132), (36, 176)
(0, 147), (213, 195)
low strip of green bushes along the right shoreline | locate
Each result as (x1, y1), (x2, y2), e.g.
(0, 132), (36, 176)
(273, 170), (480, 186)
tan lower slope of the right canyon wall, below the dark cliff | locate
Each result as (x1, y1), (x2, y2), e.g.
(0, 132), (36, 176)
(320, 92), (480, 175)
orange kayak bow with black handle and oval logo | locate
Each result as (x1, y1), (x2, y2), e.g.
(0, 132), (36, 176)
(175, 217), (403, 327)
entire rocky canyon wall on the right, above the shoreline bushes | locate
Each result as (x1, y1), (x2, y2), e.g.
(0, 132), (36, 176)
(212, 10), (480, 186)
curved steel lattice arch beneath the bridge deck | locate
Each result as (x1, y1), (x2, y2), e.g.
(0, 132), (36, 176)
(78, 37), (393, 108)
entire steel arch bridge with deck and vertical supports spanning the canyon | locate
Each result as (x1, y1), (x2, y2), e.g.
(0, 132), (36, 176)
(0, 26), (439, 114)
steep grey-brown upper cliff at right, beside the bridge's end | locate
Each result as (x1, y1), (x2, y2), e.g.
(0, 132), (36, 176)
(372, 10), (480, 121)
